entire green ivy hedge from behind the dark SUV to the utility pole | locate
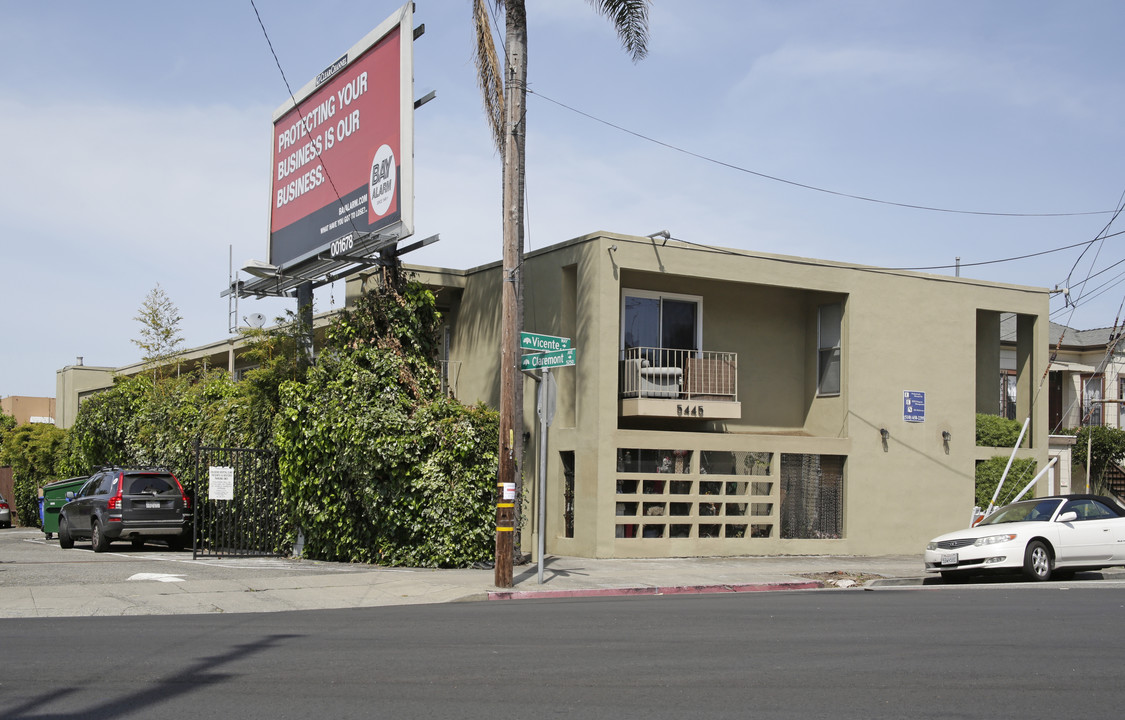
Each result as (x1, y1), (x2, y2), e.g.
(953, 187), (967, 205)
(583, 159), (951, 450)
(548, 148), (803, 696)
(39, 278), (500, 567)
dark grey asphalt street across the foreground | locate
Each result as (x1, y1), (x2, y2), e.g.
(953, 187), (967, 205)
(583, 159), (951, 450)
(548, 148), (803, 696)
(0, 583), (1125, 720)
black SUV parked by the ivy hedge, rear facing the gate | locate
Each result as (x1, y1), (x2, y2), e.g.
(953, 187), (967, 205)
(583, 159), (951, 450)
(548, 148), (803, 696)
(59, 467), (191, 552)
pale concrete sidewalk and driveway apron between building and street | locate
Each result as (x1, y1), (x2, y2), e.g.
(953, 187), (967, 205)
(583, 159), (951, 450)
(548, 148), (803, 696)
(0, 526), (923, 618)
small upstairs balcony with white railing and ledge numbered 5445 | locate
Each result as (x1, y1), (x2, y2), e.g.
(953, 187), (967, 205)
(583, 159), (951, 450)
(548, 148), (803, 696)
(621, 348), (743, 420)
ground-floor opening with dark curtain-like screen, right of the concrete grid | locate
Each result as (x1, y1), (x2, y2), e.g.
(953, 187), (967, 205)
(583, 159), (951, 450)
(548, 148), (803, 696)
(781, 453), (846, 540)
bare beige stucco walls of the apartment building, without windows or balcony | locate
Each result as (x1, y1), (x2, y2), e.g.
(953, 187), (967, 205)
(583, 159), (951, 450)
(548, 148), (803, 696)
(409, 234), (1047, 557)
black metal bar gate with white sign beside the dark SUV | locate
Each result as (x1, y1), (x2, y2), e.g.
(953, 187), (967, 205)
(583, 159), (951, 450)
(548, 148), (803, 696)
(191, 446), (293, 558)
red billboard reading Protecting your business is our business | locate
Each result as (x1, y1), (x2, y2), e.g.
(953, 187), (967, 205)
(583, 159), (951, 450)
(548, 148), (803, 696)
(269, 2), (414, 269)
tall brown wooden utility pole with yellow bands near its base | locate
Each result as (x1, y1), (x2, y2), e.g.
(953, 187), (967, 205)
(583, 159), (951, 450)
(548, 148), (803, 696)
(494, 0), (528, 587)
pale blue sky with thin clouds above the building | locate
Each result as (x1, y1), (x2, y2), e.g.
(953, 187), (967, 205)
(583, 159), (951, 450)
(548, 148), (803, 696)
(0, 0), (1125, 396)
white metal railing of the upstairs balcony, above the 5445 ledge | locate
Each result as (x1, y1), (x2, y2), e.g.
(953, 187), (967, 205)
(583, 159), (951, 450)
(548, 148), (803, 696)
(621, 348), (738, 402)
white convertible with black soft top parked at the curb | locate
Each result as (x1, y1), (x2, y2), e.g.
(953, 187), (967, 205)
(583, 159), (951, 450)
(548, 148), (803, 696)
(924, 495), (1125, 581)
